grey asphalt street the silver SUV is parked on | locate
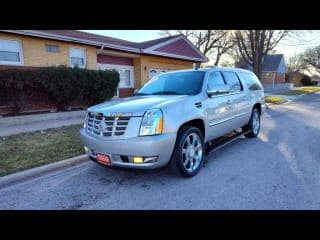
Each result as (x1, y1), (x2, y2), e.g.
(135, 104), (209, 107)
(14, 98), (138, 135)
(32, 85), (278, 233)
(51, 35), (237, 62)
(0, 93), (320, 209)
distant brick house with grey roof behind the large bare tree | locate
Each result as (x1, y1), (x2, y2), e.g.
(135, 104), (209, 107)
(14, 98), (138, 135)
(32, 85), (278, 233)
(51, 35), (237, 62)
(236, 54), (287, 85)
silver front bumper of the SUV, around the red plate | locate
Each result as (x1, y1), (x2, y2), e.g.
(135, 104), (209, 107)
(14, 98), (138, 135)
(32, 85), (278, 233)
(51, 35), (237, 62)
(80, 128), (177, 169)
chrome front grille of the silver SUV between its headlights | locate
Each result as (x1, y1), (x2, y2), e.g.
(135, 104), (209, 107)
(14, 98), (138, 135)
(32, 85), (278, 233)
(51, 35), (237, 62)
(87, 113), (130, 137)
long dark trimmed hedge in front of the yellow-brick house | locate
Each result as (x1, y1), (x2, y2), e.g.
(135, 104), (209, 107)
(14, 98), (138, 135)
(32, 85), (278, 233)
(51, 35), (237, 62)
(0, 66), (119, 113)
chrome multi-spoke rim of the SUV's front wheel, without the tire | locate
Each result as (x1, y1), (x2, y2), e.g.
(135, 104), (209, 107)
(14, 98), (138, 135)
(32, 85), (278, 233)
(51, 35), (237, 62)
(181, 133), (203, 173)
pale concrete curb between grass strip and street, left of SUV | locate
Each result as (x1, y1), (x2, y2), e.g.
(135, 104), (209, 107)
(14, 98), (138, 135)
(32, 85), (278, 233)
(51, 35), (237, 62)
(0, 154), (89, 188)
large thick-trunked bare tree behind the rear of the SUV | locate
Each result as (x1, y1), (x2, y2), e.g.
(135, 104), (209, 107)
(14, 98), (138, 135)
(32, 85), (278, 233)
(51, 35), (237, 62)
(235, 30), (288, 79)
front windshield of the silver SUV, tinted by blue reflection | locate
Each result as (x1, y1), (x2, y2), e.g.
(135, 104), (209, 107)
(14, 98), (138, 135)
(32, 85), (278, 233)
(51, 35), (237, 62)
(136, 71), (205, 95)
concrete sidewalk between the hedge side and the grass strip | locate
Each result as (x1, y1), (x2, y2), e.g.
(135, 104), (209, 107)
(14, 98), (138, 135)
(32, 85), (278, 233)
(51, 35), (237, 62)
(0, 110), (86, 137)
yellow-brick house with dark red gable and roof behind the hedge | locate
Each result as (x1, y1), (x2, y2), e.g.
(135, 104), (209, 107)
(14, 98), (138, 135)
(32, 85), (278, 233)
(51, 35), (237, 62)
(0, 30), (208, 113)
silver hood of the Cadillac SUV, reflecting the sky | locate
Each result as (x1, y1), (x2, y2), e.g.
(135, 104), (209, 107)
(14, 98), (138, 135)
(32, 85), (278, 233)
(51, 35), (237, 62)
(88, 95), (188, 116)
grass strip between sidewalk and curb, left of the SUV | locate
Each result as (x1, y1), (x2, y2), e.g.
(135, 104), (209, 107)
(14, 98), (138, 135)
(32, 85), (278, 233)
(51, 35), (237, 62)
(0, 125), (84, 176)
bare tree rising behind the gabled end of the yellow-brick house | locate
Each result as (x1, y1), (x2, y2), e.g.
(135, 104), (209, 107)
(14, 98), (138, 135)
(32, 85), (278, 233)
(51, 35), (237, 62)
(163, 30), (236, 65)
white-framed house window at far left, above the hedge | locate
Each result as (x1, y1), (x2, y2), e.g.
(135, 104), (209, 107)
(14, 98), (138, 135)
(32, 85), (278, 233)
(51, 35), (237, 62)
(0, 39), (23, 65)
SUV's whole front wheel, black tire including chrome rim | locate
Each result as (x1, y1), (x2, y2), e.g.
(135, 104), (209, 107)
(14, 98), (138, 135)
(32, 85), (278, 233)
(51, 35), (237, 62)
(169, 126), (204, 177)
